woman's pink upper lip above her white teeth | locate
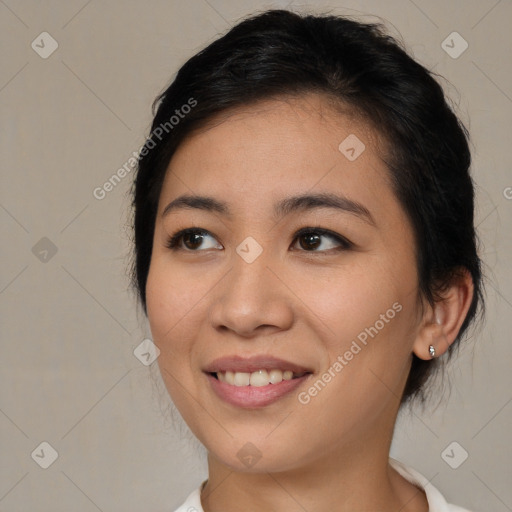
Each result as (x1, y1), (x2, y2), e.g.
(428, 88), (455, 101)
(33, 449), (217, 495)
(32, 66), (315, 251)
(204, 355), (312, 373)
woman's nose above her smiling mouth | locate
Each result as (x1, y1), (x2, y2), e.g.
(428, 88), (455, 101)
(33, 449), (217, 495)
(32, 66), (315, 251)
(210, 250), (294, 338)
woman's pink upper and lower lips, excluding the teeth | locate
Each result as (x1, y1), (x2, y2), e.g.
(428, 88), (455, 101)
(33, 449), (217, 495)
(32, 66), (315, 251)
(203, 356), (312, 409)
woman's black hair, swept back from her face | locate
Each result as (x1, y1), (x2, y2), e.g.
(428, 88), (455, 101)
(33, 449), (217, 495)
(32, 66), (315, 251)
(132, 9), (483, 404)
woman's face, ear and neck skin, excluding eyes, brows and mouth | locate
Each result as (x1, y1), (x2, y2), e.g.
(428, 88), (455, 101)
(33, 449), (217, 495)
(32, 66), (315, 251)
(146, 94), (472, 512)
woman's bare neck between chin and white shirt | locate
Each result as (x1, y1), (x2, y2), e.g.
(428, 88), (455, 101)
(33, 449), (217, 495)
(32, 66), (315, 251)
(201, 412), (428, 512)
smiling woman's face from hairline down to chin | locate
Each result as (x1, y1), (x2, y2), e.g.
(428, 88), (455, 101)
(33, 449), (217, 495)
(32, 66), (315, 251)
(146, 95), (420, 472)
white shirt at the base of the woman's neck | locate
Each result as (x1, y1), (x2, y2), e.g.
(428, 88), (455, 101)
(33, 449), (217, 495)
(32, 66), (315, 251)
(175, 459), (470, 512)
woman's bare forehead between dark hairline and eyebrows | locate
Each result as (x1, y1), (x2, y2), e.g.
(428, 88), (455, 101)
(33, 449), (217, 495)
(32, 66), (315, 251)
(160, 94), (395, 222)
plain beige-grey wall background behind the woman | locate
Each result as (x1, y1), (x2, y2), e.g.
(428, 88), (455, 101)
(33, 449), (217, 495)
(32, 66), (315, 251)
(0, 0), (512, 512)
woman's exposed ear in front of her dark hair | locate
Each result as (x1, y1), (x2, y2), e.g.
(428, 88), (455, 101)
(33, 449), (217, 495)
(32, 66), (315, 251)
(413, 268), (474, 359)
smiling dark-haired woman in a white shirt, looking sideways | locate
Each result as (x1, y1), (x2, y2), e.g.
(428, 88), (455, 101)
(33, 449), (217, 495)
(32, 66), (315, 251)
(133, 10), (482, 512)
